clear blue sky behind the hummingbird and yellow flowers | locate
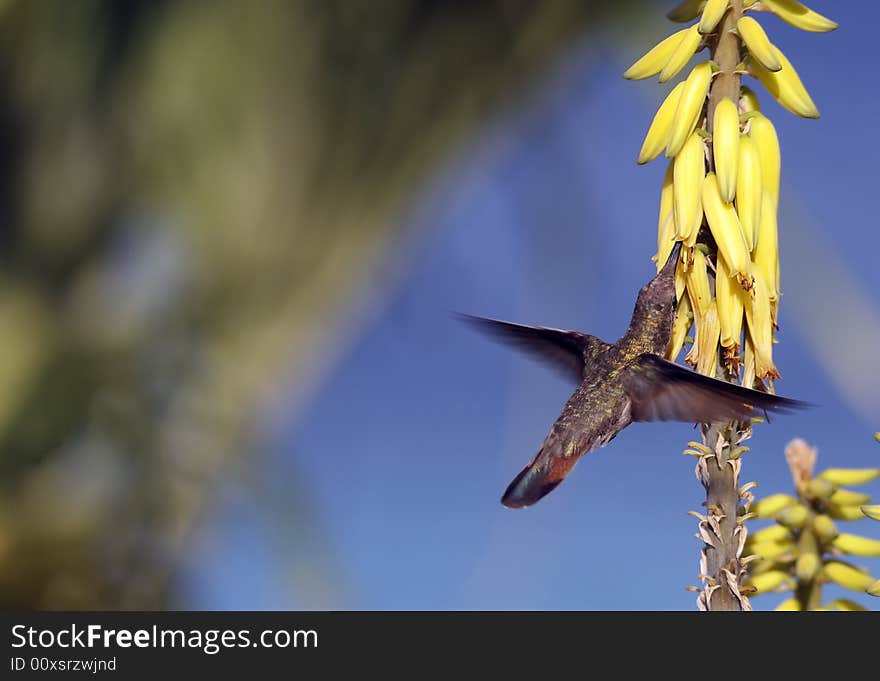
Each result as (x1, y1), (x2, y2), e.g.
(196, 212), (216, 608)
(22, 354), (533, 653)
(182, 3), (880, 610)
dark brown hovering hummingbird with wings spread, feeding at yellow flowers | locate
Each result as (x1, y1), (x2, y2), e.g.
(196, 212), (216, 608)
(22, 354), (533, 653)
(461, 242), (807, 508)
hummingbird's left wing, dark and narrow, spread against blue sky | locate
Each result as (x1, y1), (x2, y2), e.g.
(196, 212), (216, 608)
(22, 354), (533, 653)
(457, 314), (596, 383)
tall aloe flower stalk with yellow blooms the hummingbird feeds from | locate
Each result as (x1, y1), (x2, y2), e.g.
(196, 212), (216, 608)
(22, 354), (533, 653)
(624, 0), (840, 610)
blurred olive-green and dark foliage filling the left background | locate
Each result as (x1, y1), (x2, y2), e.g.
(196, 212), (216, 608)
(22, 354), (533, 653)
(0, 0), (632, 609)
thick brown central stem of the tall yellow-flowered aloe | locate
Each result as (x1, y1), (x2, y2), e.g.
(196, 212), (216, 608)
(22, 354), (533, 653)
(702, 0), (745, 611)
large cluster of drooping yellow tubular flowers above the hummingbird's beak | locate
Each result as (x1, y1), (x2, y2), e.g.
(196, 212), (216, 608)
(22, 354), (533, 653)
(624, 0), (837, 388)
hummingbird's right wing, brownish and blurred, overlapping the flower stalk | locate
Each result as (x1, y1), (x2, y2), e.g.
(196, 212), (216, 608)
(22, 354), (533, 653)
(623, 354), (810, 423)
